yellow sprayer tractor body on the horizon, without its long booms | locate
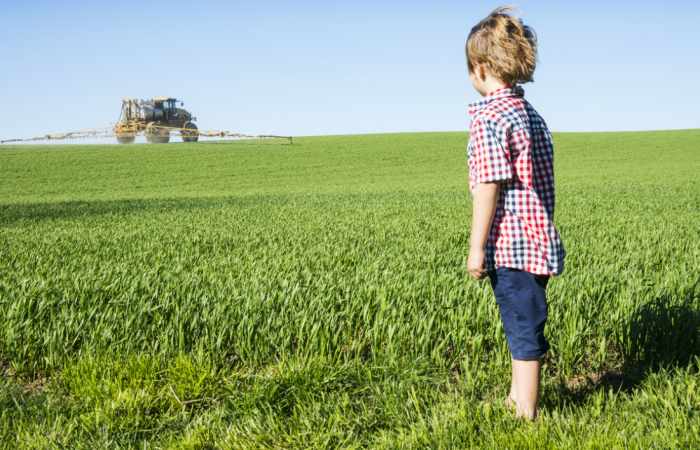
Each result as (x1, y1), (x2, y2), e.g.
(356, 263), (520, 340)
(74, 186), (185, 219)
(114, 97), (199, 144)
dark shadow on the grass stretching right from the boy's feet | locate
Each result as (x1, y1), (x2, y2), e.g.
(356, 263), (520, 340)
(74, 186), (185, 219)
(542, 290), (700, 409)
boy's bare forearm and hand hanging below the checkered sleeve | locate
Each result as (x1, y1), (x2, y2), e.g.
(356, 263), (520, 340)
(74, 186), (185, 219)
(467, 182), (500, 278)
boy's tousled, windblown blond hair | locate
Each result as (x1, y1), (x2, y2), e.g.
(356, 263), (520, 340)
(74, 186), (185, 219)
(465, 6), (537, 85)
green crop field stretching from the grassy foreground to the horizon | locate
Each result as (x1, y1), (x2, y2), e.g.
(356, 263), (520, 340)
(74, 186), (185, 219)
(0, 130), (700, 449)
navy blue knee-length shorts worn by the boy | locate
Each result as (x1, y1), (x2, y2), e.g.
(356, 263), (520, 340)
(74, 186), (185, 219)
(488, 267), (549, 360)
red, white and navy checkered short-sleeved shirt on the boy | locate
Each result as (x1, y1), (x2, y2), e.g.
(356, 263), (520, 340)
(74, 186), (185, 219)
(467, 85), (566, 275)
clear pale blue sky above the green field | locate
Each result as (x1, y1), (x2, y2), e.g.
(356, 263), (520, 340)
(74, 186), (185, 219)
(0, 0), (700, 138)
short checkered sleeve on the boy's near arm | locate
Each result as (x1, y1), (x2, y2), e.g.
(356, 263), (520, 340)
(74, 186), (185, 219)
(469, 117), (513, 190)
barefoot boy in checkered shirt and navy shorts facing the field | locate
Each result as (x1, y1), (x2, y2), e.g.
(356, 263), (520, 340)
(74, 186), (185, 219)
(466, 7), (566, 419)
